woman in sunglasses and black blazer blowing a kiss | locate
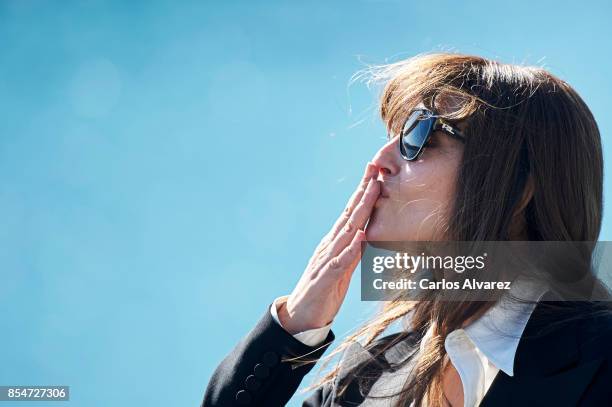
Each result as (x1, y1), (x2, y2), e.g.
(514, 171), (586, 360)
(202, 53), (612, 406)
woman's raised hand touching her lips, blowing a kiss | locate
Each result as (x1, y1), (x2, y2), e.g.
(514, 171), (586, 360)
(278, 163), (380, 334)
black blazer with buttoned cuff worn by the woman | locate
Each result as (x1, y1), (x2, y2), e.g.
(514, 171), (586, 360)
(202, 302), (612, 407)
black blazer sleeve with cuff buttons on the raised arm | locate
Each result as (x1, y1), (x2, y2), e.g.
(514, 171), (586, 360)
(201, 304), (335, 407)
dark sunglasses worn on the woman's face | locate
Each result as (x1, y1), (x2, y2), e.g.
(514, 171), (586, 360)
(399, 109), (465, 161)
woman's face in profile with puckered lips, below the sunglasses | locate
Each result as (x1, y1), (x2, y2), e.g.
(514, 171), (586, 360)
(366, 127), (463, 241)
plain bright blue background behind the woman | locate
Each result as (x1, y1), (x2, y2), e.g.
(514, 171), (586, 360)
(0, 0), (612, 406)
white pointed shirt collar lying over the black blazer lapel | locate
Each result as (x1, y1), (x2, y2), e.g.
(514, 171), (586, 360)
(464, 277), (546, 376)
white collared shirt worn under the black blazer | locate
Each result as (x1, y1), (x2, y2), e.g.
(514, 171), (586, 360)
(270, 279), (546, 407)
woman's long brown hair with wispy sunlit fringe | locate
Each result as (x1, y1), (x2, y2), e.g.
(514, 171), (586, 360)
(298, 53), (603, 406)
